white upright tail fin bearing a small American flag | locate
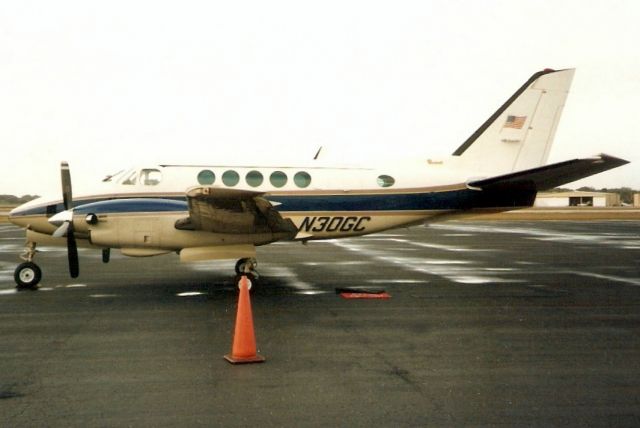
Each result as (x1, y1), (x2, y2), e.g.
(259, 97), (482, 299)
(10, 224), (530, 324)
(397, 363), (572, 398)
(453, 69), (575, 173)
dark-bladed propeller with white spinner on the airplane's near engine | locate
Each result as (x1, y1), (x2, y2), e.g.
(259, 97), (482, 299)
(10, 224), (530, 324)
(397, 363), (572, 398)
(49, 162), (80, 278)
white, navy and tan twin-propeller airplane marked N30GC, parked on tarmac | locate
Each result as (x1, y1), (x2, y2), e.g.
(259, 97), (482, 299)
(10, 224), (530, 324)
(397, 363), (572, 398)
(9, 69), (628, 289)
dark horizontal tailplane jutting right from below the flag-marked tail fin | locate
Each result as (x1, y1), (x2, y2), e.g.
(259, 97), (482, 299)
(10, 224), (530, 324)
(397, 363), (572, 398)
(467, 154), (629, 191)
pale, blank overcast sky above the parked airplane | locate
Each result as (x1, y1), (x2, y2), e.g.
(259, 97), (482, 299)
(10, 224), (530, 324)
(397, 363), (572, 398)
(0, 0), (640, 195)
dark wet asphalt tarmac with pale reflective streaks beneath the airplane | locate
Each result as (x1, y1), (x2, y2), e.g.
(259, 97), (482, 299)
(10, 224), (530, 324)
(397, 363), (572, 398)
(0, 221), (640, 427)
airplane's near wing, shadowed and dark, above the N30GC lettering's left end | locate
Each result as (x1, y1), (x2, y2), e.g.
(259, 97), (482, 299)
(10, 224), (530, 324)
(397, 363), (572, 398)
(176, 187), (298, 239)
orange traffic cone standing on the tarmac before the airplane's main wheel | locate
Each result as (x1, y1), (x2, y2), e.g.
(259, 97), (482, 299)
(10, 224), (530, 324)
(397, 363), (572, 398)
(224, 275), (264, 364)
